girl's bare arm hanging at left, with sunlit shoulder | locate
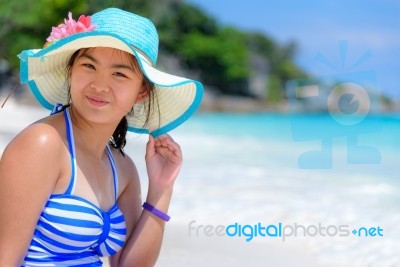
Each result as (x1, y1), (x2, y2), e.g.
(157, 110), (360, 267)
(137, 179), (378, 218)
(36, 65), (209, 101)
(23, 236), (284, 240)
(0, 123), (62, 266)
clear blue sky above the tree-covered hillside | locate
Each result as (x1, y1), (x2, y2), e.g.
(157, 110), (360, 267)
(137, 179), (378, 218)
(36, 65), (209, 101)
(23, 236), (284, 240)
(186, 0), (400, 99)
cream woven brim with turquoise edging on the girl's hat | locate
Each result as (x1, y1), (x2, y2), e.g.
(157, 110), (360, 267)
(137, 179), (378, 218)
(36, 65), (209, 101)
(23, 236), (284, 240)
(19, 32), (203, 137)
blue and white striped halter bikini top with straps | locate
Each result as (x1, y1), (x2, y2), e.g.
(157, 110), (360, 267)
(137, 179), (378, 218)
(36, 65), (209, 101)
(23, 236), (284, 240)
(23, 109), (126, 266)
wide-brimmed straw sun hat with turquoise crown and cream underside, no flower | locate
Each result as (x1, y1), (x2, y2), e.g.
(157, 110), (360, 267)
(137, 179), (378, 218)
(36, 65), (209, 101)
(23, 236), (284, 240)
(19, 8), (203, 136)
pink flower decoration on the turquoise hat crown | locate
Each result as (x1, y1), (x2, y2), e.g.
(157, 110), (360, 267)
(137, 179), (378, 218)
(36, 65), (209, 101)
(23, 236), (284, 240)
(44, 12), (96, 47)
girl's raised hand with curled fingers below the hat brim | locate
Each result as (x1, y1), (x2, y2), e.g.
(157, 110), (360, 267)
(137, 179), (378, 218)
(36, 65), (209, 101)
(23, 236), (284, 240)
(146, 134), (182, 191)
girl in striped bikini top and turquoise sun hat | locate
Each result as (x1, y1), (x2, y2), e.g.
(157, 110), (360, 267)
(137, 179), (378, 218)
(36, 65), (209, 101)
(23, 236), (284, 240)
(0, 8), (202, 267)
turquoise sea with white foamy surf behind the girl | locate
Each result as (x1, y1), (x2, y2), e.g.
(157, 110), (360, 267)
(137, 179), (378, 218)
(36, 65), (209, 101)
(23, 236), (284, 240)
(0, 107), (400, 267)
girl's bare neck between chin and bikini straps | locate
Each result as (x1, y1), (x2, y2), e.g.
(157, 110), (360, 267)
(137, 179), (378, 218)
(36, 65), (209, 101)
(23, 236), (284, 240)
(70, 107), (117, 158)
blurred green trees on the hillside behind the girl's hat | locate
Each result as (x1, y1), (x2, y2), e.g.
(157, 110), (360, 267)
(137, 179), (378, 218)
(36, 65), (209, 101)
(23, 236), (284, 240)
(0, 0), (305, 101)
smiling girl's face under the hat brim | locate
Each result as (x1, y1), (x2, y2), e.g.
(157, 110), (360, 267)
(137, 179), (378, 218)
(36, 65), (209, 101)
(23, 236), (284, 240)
(70, 47), (146, 127)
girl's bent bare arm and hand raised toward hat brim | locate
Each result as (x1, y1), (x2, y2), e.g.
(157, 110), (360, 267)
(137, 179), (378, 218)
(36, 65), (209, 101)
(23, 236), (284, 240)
(110, 135), (182, 267)
